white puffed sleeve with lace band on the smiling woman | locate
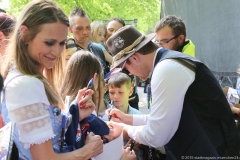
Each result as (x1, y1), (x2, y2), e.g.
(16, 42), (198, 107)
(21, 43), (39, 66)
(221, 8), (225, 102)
(5, 76), (55, 148)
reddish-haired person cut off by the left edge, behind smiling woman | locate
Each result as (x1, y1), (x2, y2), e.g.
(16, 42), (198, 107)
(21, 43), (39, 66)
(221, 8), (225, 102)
(0, 12), (15, 67)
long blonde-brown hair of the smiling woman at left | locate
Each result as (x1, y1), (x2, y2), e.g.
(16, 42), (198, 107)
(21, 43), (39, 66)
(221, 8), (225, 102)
(1, 0), (69, 107)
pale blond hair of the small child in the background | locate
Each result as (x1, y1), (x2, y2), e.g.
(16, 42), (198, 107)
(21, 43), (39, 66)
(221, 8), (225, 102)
(90, 21), (107, 43)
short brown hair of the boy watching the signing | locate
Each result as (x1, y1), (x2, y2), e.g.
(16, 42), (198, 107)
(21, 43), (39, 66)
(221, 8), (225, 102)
(108, 72), (132, 89)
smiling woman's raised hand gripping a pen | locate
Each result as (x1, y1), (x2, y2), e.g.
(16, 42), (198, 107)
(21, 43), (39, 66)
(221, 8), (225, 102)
(76, 88), (95, 121)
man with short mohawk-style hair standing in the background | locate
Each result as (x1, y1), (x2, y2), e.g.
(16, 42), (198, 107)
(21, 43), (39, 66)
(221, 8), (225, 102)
(69, 7), (108, 74)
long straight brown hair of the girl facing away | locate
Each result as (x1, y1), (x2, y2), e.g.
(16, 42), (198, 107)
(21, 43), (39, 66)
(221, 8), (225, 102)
(60, 50), (103, 113)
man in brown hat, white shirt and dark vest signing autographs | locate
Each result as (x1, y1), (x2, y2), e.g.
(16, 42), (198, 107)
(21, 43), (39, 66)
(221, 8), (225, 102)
(107, 26), (239, 159)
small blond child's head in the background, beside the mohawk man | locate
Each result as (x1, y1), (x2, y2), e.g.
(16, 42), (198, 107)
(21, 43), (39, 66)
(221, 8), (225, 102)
(91, 21), (107, 45)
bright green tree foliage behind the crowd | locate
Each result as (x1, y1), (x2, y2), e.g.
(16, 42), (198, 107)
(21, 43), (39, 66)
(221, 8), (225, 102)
(5, 0), (161, 33)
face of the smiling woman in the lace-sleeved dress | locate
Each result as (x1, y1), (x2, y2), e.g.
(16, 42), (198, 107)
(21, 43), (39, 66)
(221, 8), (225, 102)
(27, 22), (68, 72)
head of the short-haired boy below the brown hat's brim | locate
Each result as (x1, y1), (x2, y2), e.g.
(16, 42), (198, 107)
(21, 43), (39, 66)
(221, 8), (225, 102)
(108, 72), (133, 108)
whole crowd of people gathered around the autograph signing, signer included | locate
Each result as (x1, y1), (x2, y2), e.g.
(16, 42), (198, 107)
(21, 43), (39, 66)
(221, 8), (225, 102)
(0, 0), (240, 160)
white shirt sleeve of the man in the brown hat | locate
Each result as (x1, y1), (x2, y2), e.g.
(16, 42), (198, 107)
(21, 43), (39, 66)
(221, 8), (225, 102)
(128, 59), (195, 148)
